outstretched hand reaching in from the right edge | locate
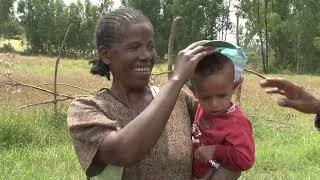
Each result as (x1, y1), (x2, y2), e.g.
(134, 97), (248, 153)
(260, 78), (320, 114)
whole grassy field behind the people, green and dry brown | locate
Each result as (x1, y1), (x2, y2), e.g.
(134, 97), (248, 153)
(0, 52), (320, 180)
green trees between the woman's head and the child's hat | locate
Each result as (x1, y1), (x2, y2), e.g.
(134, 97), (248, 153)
(122, 0), (231, 59)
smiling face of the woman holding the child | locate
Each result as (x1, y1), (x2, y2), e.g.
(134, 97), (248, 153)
(107, 23), (157, 88)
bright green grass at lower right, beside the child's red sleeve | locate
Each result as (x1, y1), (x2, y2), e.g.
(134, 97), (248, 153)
(241, 113), (320, 180)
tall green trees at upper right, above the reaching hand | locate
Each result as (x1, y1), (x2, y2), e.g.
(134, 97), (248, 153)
(240, 0), (320, 73)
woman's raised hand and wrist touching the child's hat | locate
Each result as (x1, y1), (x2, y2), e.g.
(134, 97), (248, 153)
(171, 40), (214, 83)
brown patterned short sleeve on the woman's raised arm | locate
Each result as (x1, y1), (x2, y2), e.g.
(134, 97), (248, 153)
(68, 98), (118, 175)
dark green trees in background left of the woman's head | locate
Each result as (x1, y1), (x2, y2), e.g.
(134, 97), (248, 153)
(17, 0), (110, 57)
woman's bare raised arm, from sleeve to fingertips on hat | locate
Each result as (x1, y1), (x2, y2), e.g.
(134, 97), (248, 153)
(95, 41), (213, 166)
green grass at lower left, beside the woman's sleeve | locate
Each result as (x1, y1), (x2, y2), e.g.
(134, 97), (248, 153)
(0, 108), (84, 179)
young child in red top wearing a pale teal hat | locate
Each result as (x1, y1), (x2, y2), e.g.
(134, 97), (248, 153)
(189, 41), (255, 179)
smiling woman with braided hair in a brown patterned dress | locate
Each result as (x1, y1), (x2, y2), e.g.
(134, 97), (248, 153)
(68, 8), (239, 179)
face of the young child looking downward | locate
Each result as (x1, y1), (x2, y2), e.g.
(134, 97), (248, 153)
(192, 70), (236, 115)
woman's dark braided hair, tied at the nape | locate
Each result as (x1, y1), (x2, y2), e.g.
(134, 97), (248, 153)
(90, 7), (152, 80)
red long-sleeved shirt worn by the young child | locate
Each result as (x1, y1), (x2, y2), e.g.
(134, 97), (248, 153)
(192, 104), (255, 177)
